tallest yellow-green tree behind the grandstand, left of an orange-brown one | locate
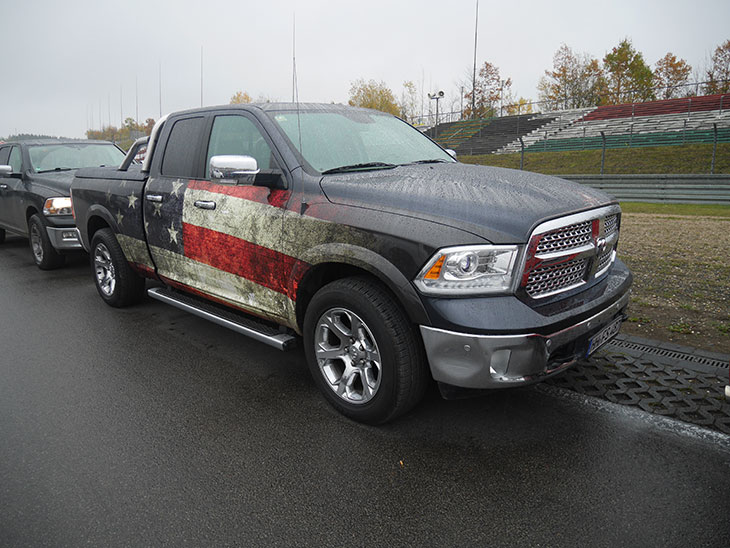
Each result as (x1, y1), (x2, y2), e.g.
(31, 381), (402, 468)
(602, 38), (654, 105)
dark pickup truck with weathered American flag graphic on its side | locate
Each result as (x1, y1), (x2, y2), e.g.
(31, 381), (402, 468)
(72, 104), (632, 423)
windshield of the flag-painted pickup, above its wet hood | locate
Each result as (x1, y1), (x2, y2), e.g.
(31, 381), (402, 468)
(269, 110), (454, 173)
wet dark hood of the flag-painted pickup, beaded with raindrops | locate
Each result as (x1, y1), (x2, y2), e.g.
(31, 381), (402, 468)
(320, 163), (612, 244)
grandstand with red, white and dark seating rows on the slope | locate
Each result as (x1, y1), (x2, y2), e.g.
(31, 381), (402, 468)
(429, 94), (730, 155)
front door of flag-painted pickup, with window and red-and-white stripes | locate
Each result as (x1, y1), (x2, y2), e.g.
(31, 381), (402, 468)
(142, 112), (294, 319)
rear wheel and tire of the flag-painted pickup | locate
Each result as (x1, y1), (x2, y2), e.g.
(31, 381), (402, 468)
(91, 228), (144, 308)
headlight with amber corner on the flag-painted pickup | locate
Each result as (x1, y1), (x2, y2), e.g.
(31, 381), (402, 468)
(414, 245), (519, 295)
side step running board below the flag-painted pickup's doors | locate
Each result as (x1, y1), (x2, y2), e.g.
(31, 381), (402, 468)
(147, 287), (297, 350)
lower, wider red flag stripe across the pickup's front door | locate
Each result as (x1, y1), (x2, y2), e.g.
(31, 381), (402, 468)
(183, 223), (309, 300)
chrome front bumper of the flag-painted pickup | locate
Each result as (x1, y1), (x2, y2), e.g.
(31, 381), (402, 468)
(420, 291), (629, 389)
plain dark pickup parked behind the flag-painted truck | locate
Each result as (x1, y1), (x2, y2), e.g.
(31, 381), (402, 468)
(0, 139), (124, 270)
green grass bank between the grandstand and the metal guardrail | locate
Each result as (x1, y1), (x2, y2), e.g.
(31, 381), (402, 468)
(459, 143), (730, 175)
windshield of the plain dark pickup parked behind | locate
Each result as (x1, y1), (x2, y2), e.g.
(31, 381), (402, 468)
(28, 143), (124, 173)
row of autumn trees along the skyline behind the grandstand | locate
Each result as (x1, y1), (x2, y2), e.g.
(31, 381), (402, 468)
(348, 38), (730, 121)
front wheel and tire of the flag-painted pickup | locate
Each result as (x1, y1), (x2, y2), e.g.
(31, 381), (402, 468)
(304, 278), (429, 424)
